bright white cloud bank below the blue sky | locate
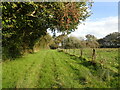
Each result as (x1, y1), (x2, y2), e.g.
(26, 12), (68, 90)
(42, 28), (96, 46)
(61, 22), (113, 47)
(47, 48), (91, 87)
(70, 16), (118, 38)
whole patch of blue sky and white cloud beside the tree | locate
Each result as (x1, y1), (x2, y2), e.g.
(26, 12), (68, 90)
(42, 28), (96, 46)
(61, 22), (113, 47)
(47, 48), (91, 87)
(70, 2), (118, 39)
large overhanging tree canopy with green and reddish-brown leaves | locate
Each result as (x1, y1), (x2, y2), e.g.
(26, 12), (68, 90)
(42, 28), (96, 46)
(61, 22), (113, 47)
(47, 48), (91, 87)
(2, 2), (91, 57)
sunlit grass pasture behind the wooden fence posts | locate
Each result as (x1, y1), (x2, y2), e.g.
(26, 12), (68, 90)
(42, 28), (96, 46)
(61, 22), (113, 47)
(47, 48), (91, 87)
(64, 48), (119, 72)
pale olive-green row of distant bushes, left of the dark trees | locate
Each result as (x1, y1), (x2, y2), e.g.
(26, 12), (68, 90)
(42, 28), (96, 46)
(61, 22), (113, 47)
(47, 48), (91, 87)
(62, 36), (99, 49)
